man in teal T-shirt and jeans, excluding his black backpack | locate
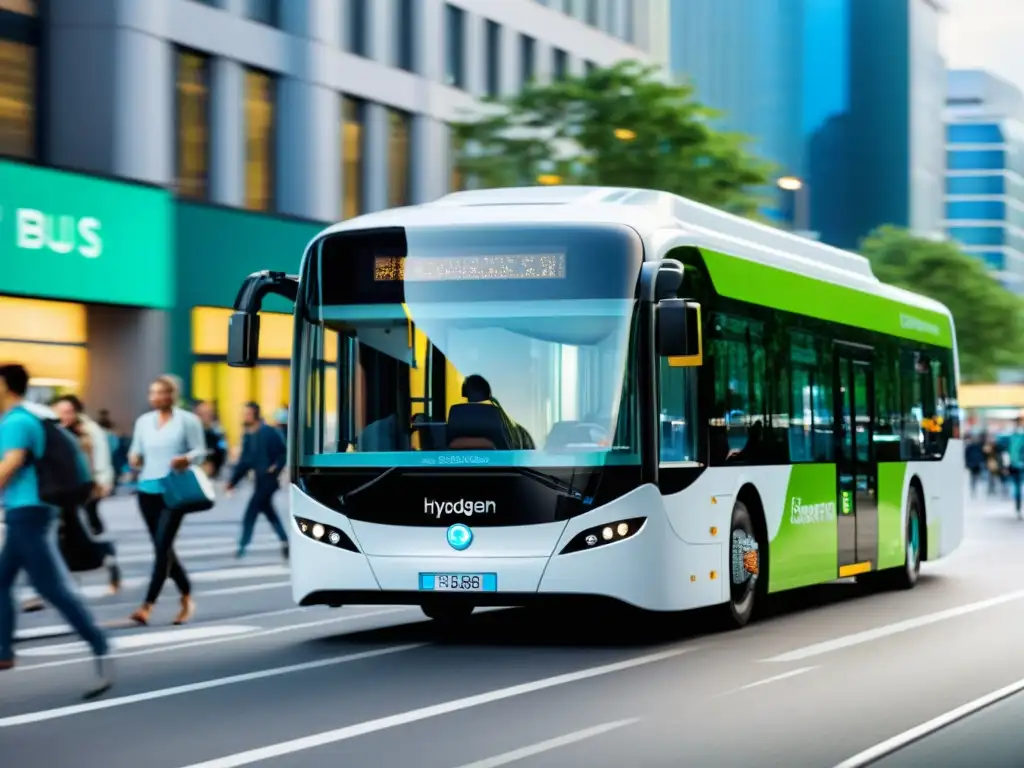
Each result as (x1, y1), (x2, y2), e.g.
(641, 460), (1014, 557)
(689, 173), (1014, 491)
(0, 364), (113, 698)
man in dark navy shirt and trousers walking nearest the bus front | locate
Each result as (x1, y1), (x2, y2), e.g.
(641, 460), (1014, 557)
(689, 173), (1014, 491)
(227, 402), (288, 560)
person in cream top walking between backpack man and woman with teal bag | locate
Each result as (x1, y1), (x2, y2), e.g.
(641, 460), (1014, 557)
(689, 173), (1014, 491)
(53, 394), (121, 595)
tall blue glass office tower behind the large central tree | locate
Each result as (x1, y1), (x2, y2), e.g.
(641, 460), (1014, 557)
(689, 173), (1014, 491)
(670, 0), (945, 248)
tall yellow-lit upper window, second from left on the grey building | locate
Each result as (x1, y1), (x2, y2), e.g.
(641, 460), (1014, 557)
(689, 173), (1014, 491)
(175, 51), (210, 200)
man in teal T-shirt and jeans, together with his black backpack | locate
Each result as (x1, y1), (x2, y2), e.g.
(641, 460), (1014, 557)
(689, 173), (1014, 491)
(0, 364), (113, 698)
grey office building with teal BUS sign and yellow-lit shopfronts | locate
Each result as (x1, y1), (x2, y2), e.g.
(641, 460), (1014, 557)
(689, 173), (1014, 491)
(0, 0), (668, 434)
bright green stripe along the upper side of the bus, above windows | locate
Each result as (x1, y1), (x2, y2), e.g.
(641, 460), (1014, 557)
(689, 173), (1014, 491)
(700, 249), (953, 347)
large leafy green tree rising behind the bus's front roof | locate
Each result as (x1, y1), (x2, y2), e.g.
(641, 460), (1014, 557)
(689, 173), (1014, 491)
(453, 61), (772, 215)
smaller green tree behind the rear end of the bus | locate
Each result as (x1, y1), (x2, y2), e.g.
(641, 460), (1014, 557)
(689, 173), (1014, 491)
(861, 226), (1024, 381)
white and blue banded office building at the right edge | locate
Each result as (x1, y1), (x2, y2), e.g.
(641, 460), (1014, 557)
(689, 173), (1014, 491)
(945, 70), (1024, 293)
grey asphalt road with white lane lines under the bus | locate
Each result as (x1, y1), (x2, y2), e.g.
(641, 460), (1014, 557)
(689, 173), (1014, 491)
(0, 483), (1024, 768)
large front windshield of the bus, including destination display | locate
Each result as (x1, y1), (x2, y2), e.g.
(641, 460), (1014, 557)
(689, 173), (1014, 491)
(297, 219), (642, 467)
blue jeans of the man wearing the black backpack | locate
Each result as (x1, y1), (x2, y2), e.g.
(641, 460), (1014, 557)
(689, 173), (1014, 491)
(0, 507), (109, 660)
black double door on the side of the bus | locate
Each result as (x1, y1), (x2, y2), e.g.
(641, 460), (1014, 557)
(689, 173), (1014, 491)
(834, 343), (879, 578)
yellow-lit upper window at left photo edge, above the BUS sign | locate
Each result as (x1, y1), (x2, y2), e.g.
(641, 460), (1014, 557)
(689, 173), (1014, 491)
(0, 40), (36, 158)
